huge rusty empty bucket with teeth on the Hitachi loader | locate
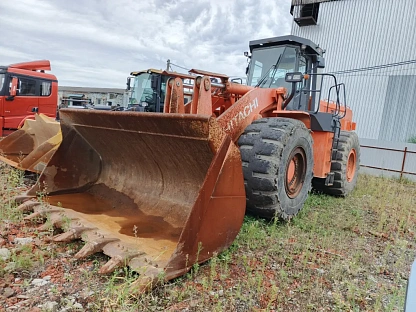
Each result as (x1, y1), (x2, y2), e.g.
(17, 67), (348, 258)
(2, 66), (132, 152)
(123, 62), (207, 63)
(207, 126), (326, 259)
(21, 109), (246, 283)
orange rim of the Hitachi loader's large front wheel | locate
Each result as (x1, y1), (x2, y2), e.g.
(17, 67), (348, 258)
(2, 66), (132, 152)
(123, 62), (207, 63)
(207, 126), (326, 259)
(285, 147), (306, 198)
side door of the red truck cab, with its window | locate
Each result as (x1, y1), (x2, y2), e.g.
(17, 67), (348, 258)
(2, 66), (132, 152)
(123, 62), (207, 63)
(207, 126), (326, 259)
(3, 75), (39, 129)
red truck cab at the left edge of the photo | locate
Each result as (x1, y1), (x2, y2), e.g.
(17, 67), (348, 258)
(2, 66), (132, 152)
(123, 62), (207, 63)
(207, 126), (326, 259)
(0, 60), (58, 136)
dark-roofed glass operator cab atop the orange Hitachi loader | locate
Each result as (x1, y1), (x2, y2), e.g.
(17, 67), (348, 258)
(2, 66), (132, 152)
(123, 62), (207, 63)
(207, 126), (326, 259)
(247, 36), (325, 111)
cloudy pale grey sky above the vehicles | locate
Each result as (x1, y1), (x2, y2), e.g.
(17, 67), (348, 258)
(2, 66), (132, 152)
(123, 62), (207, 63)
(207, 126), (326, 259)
(0, 0), (292, 88)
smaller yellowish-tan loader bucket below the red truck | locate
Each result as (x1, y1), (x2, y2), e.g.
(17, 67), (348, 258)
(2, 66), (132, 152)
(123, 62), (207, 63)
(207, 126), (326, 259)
(0, 114), (62, 173)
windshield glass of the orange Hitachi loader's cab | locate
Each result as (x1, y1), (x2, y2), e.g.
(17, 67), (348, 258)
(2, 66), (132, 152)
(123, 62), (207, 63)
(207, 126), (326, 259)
(248, 47), (297, 89)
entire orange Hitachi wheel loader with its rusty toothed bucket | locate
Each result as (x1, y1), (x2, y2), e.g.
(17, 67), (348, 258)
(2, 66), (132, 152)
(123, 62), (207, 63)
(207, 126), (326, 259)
(16, 36), (360, 287)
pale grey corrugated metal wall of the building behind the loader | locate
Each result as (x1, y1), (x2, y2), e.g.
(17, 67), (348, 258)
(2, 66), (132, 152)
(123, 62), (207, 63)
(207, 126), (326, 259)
(291, 0), (416, 141)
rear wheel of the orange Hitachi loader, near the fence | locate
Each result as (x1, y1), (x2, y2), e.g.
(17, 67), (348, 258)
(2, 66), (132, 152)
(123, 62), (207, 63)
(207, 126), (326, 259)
(312, 131), (360, 196)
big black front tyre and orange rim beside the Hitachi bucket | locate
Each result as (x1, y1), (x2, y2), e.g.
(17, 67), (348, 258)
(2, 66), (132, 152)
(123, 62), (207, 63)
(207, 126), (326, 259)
(238, 118), (313, 220)
